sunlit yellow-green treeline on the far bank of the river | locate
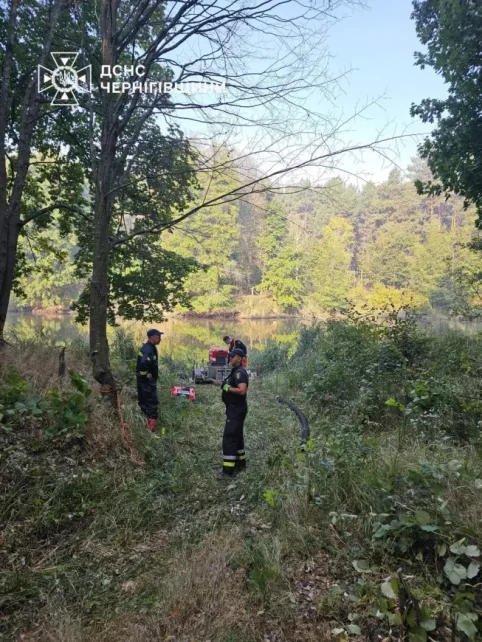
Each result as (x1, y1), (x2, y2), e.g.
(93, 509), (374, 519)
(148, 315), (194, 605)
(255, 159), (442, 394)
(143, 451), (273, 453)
(15, 159), (478, 315)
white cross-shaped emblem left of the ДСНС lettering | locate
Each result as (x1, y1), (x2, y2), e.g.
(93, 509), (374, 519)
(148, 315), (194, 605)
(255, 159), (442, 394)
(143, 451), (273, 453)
(38, 51), (92, 106)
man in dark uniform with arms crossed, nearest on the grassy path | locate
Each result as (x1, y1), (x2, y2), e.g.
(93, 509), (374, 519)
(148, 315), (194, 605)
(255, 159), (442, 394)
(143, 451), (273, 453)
(217, 348), (249, 479)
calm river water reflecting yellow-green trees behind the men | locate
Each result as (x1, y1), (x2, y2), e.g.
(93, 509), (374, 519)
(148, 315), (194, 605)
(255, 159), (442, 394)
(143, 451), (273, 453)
(6, 314), (482, 362)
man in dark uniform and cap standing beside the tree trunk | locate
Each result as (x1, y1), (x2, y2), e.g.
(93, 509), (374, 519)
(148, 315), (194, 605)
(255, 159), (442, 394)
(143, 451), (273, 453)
(136, 329), (164, 432)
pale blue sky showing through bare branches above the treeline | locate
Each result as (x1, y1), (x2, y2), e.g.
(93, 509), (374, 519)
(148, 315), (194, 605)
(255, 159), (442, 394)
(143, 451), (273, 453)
(168, 0), (447, 186)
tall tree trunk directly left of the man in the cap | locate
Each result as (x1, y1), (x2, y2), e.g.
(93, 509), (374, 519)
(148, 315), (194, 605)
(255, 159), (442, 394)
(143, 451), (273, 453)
(89, 0), (118, 390)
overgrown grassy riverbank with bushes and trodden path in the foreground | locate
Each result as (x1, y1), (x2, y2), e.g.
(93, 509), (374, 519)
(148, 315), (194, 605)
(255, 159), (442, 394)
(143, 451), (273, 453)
(0, 319), (482, 642)
